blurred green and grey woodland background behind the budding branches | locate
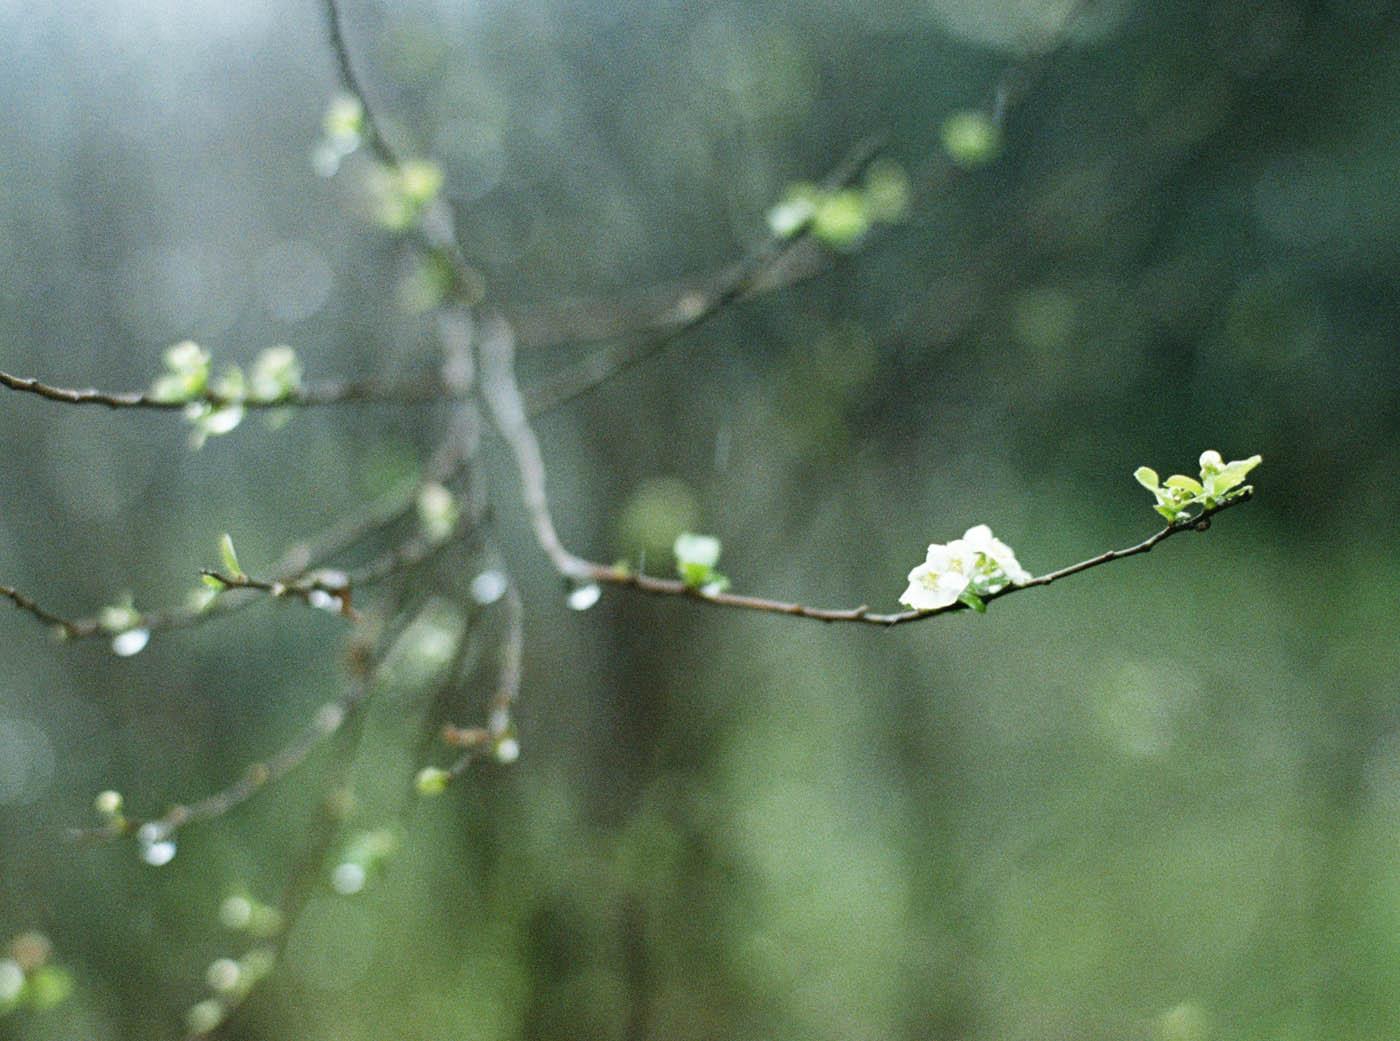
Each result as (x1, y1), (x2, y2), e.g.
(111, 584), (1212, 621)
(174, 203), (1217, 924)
(0, 0), (1400, 1041)
